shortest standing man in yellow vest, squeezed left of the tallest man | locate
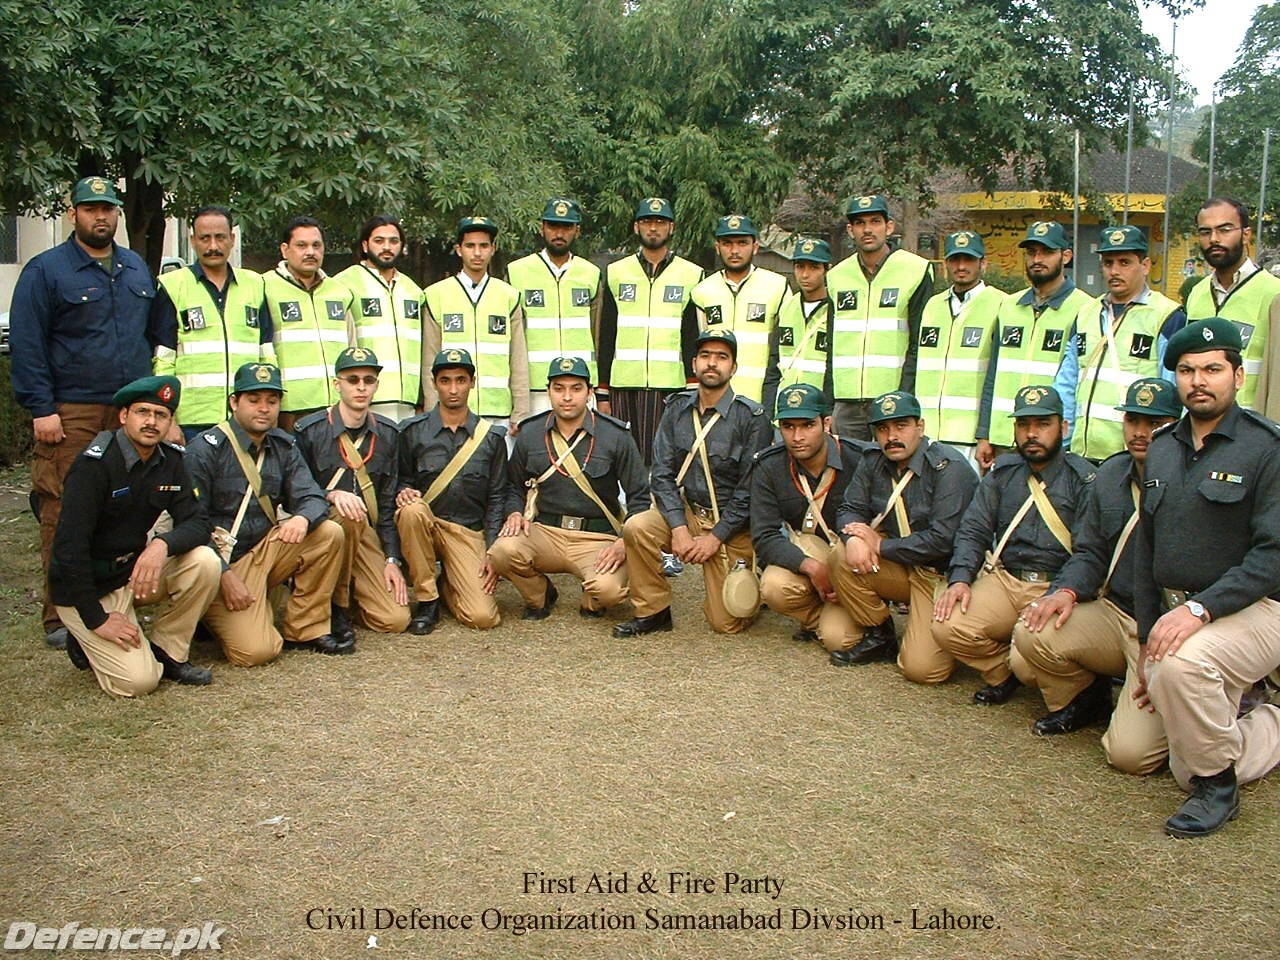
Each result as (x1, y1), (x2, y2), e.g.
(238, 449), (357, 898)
(773, 237), (831, 402)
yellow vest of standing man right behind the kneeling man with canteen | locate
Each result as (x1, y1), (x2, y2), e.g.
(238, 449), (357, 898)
(692, 266), (790, 403)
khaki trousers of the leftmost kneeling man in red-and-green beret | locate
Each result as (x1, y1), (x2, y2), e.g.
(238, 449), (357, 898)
(56, 547), (223, 696)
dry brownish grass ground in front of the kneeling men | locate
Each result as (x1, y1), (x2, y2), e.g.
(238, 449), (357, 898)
(0, 474), (1280, 960)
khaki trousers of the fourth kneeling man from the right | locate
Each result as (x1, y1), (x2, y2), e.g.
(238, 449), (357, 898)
(828, 545), (955, 684)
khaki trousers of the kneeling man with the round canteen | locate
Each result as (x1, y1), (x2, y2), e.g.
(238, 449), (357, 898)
(622, 507), (754, 634)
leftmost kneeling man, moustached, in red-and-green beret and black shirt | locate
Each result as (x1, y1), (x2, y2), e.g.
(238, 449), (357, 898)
(49, 376), (221, 696)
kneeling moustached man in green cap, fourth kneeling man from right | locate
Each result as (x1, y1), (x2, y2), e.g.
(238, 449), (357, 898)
(828, 390), (978, 684)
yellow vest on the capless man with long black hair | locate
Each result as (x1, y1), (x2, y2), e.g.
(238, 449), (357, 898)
(337, 264), (422, 406)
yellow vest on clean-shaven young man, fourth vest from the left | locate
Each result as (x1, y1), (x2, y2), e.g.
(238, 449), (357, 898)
(422, 275), (517, 419)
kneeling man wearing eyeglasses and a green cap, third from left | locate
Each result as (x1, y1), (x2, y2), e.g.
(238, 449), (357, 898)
(296, 347), (410, 643)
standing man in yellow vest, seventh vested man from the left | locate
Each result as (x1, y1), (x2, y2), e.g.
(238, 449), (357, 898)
(689, 214), (790, 410)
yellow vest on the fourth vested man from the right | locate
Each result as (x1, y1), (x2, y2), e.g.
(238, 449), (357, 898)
(915, 287), (1006, 445)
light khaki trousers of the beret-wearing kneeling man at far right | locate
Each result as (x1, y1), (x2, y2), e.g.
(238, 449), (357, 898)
(1147, 598), (1280, 790)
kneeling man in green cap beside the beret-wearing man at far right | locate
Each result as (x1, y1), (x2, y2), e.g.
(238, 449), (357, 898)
(1009, 378), (1181, 752)
